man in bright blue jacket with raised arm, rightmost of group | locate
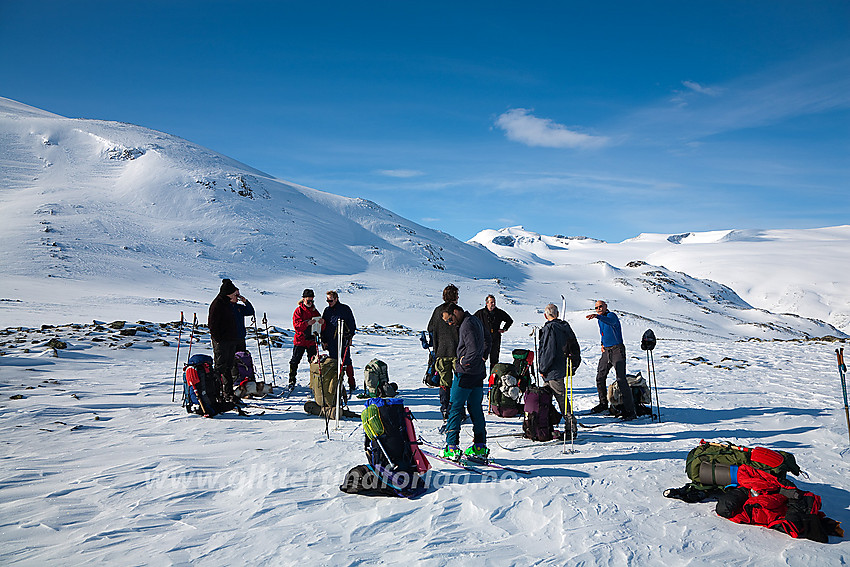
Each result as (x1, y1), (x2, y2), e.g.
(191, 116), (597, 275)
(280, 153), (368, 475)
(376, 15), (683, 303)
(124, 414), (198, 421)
(587, 299), (636, 421)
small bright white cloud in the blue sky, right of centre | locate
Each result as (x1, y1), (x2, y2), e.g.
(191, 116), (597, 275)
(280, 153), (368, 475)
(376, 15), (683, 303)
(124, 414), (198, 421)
(496, 108), (608, 148)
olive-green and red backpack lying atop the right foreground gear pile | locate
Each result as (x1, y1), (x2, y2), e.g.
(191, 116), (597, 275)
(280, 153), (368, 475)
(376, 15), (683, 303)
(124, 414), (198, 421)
(685, 440), (800, 490)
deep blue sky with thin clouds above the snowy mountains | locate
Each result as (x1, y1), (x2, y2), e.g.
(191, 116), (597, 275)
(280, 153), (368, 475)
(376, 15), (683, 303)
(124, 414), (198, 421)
(0, 0), (850, 241)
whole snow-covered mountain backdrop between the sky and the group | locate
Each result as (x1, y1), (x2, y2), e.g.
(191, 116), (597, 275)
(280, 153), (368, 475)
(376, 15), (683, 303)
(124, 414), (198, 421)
(0, 99), (850, 338)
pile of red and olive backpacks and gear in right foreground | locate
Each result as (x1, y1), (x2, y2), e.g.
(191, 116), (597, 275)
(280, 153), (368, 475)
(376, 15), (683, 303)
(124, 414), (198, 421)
(664, 441), (844, 543)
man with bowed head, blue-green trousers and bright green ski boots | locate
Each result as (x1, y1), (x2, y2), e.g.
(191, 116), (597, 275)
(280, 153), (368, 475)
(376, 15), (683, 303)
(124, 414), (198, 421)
(442, 303), (490, 459)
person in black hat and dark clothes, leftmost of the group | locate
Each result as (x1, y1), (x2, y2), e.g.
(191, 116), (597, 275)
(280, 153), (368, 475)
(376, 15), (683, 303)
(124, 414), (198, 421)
(207, 279), (254, 400)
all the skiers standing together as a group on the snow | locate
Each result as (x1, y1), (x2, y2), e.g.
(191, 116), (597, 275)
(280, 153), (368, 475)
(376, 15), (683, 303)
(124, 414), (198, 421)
(208, 279), (636, 458)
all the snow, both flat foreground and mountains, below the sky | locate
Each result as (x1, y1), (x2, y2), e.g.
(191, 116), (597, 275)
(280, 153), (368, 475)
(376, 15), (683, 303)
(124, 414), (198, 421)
(0, 99), (850, 566)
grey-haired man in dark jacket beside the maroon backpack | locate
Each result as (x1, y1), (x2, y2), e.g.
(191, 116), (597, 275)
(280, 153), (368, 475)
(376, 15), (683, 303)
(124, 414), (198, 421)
(537, 303), (581, 439)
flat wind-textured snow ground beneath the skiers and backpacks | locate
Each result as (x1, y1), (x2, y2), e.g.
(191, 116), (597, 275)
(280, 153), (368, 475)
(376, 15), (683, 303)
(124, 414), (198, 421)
(0, 329), (850, 566)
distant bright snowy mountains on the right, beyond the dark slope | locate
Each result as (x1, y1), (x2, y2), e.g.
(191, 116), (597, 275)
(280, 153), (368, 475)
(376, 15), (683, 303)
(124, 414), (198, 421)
(469, 226), (850, 337)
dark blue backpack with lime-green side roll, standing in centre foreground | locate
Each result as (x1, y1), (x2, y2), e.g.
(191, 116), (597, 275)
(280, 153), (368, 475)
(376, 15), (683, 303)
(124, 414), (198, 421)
(339, 398), (431, 498)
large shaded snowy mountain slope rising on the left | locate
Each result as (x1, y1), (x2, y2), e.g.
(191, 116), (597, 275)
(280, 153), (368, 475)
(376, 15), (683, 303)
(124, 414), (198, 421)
(0, 99), (523, 328)
